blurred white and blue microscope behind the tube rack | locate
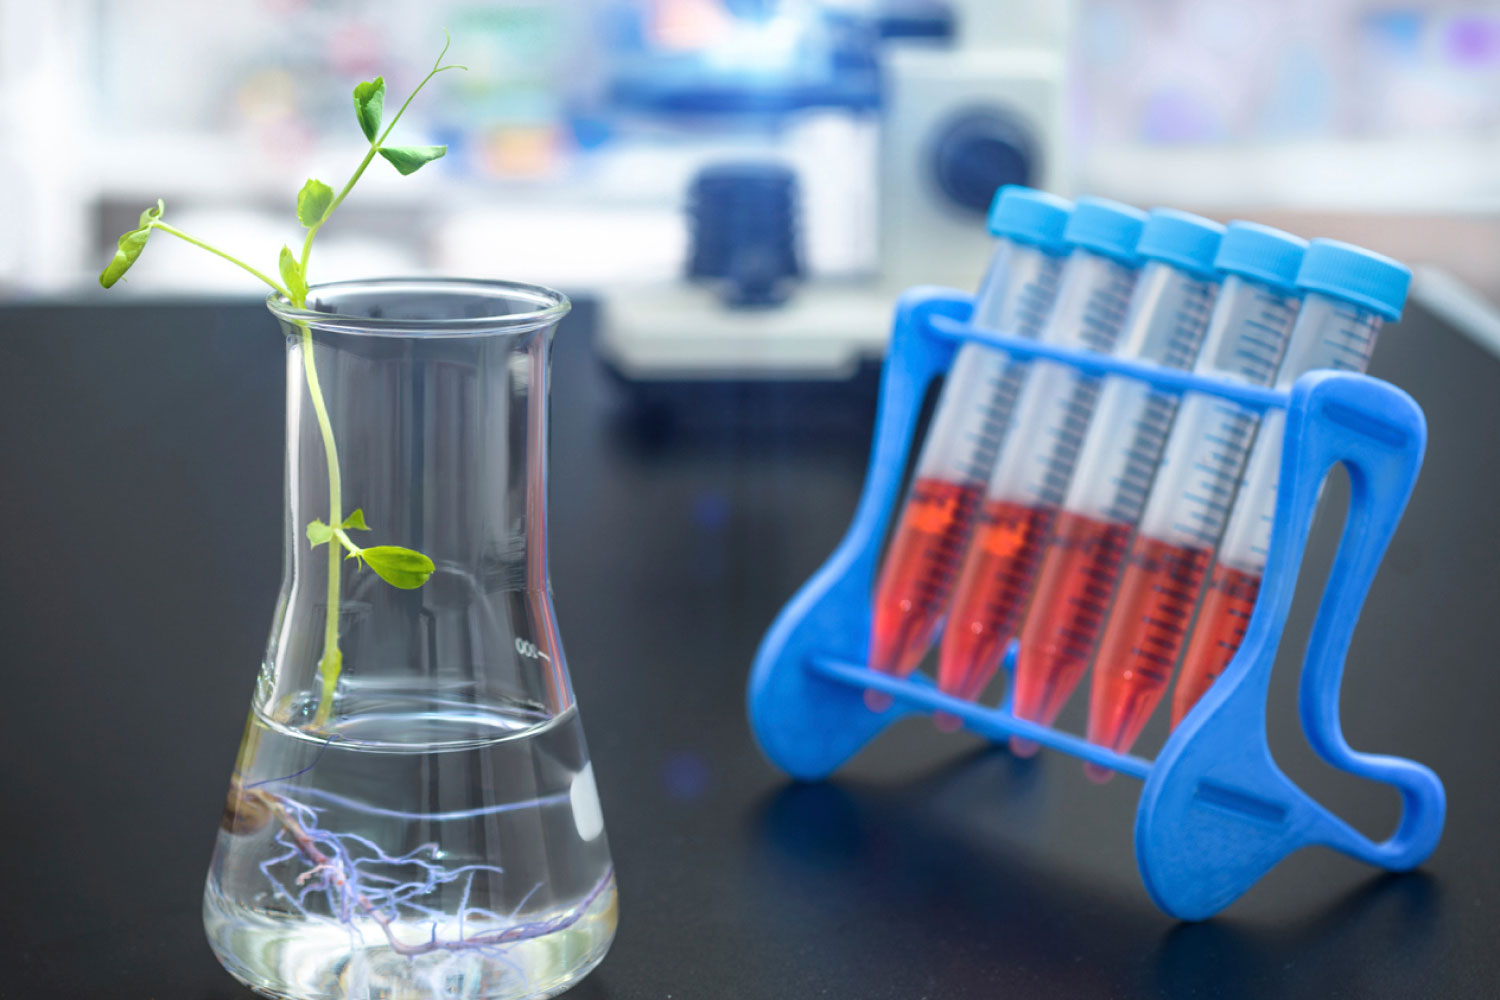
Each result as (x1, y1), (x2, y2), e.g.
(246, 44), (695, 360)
(600, 0), (1068, 390)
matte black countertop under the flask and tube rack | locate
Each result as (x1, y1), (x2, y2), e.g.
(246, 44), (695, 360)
(0, 303), (1500, 1000)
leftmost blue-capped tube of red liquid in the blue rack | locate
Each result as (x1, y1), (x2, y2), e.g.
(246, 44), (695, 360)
(866, 184), (1071, 711)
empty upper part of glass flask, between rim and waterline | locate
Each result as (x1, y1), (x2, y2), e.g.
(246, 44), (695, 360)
(258, 313), (573, 728)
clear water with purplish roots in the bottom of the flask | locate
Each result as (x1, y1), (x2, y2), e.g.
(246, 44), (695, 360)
(204, 708), (617, 1000)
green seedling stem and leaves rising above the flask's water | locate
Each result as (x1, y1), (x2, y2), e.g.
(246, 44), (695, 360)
(99, 31), (467, 729)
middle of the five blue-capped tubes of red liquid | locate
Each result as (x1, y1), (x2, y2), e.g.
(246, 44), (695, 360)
(1011, 208), (1224, 754)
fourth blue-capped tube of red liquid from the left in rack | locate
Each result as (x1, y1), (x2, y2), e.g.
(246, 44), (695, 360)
(1091, 222), (1307, 777)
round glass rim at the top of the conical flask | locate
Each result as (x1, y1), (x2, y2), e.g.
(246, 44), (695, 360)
(266, 277), (573, 337)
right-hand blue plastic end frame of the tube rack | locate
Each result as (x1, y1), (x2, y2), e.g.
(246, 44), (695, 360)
(1136, 372), (1445, 919)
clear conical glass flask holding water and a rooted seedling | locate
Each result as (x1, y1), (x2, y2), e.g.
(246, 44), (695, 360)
(204, 280), (617, 1000)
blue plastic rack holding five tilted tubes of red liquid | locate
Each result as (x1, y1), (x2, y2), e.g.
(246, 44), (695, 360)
(749, 288), (1446, 921)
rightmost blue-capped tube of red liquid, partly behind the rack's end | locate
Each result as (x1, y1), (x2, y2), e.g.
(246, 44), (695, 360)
(1164, 240), (1412, 731)
